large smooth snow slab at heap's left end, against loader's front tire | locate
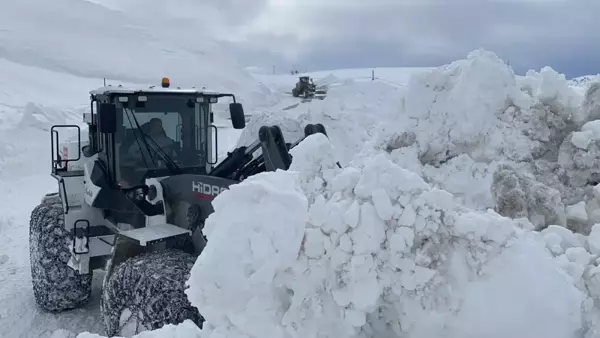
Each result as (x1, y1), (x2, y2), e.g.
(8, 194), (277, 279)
(186, 171), (308, 337)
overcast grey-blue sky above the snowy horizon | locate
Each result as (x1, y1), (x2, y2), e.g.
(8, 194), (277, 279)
(200, 0), (600, 77)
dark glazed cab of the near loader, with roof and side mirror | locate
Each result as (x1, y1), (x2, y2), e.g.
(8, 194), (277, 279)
(85, 78), (245, 185)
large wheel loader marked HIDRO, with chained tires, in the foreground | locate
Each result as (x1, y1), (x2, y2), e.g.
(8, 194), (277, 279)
(29, 81), (326, 336)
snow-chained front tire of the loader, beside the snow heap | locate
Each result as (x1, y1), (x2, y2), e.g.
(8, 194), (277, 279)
(101, 250), (203, 336)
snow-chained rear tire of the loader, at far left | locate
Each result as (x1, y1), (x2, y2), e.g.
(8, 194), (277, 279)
(29, 195), (92, 312)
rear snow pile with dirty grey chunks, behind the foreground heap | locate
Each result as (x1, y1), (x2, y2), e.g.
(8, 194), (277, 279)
(364, 50), (600, 233)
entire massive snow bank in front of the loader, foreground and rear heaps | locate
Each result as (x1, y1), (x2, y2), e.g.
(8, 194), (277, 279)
(63, 51), (600, 338)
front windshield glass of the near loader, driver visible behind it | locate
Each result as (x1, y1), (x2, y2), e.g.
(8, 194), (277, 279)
(115, 97), (209, 184)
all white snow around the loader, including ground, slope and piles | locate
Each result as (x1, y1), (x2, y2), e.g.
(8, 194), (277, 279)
(0, 0), (600, 338)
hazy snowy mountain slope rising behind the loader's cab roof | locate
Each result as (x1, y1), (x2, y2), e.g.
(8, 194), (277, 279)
(0, 0), (268, 112)
